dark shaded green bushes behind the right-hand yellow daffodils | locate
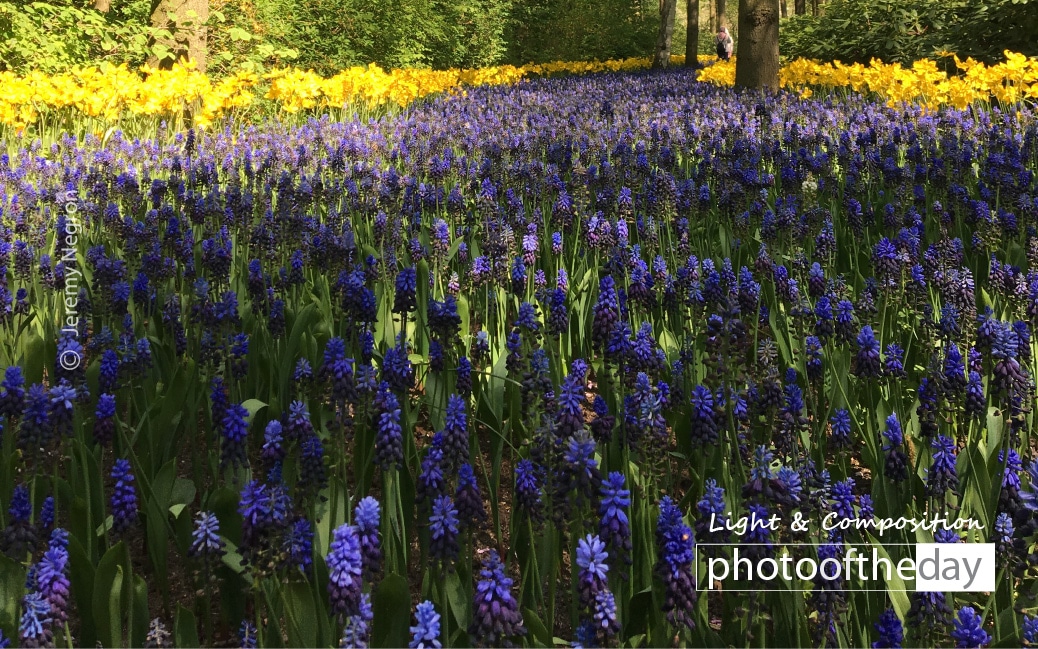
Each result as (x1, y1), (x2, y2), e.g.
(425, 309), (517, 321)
(779, 0), (1038, 63)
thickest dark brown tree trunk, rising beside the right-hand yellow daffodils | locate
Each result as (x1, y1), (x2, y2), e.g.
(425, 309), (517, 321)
(735, 0), (779, 89)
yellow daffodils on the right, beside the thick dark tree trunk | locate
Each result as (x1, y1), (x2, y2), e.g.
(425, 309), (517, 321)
(700, 51), (1038, 109)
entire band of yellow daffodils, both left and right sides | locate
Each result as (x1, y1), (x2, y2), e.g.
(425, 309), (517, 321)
(0, 51), (1038, 128)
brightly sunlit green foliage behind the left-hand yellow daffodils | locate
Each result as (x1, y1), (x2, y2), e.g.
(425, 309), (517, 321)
(0, 0), (511, 76)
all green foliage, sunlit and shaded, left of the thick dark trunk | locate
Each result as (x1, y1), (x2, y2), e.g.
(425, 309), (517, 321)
(0, 0), (668, 76)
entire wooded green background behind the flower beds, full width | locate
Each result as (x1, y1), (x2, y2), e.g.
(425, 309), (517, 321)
(0, 0), (1038, 76)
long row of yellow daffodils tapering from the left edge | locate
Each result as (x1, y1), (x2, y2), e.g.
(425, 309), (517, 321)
(0, 58), (664, 128)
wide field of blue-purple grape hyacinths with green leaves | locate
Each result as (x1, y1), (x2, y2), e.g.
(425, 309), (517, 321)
(0, 72), (1038, 647)
